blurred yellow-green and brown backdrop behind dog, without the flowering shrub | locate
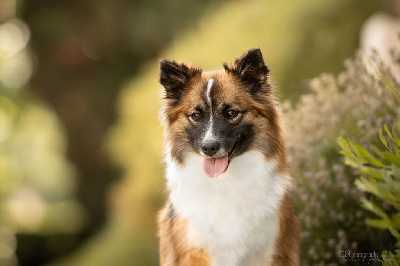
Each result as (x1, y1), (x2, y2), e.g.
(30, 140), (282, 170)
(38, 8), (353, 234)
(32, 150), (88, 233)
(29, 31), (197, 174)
(0, 0), (398, 266)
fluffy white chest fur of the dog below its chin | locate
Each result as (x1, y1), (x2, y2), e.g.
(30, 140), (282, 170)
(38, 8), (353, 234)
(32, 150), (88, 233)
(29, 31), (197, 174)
(166, 151), (288, 266)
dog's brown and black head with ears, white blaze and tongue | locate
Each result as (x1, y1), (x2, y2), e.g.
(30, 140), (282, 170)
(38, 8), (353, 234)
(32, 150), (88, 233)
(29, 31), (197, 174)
(160, 49), (280, 177)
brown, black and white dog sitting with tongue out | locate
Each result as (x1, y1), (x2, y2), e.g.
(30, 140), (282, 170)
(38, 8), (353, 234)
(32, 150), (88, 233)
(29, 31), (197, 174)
(158, 48), (300, 266)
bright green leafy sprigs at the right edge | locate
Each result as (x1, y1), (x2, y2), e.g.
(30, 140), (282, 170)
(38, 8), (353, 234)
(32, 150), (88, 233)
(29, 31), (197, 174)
(337, 120), (400, 265)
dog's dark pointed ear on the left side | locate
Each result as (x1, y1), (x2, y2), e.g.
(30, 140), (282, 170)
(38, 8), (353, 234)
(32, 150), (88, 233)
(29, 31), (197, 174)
(159, 60), (202, 100)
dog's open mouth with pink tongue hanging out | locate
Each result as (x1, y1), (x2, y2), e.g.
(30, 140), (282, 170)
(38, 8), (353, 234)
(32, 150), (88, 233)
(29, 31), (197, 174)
(203, 136), (240, 178)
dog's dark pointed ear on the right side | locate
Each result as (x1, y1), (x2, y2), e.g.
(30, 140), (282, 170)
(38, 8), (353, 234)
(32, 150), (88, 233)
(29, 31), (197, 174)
(224, 48), (270, 93)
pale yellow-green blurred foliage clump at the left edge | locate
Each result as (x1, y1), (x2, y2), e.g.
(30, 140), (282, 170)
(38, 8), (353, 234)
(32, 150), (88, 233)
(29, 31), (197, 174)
(0, 95), (83, 231)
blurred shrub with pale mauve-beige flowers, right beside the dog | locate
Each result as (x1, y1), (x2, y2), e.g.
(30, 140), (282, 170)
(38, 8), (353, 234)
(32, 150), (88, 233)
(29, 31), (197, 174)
(284, 53), (400, 265)
